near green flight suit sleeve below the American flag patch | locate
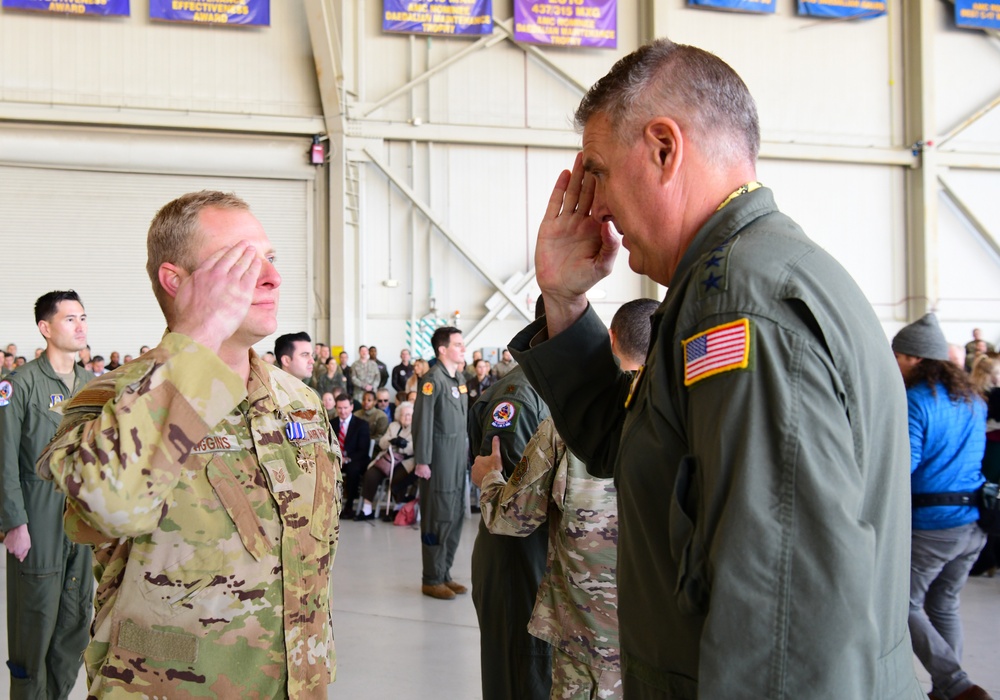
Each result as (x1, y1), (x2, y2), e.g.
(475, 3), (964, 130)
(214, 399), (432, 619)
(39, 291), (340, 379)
(680, 314), (884, 700)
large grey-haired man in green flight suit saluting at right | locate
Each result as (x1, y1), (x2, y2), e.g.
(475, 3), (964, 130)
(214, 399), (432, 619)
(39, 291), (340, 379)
(509, 39), (923, 700)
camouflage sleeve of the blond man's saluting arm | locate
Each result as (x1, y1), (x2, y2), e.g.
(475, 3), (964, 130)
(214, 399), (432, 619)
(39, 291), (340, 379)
(38, 333), (246, 537)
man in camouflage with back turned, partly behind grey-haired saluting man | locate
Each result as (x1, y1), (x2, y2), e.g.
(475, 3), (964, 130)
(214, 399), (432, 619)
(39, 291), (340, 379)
(472, 299), (658, 699)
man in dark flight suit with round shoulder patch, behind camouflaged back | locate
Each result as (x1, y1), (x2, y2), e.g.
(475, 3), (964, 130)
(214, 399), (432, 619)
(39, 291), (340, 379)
(469, 297), (552, 700)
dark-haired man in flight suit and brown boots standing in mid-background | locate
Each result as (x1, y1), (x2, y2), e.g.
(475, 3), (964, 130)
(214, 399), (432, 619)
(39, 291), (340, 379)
(413, 326), (469, 600)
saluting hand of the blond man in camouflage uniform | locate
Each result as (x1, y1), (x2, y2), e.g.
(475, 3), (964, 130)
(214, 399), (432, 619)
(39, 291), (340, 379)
(171, 241), (262, 351)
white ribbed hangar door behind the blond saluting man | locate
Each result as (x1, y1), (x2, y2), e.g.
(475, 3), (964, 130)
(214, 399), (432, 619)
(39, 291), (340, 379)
(0, 166), (312, 359)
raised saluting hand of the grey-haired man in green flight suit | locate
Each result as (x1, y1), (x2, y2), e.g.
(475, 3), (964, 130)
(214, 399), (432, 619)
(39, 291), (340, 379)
(535, 153), (621, 335)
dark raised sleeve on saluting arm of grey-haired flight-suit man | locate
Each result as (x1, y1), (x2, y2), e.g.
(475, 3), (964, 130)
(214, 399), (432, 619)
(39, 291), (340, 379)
(508, 306), (631, 477)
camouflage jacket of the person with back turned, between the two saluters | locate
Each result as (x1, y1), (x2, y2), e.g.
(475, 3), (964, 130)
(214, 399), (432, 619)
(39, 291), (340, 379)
(479, 418), (620, 671)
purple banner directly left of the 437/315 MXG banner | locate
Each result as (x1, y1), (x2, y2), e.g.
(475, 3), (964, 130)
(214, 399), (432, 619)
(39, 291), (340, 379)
(382, 0), (493, 36)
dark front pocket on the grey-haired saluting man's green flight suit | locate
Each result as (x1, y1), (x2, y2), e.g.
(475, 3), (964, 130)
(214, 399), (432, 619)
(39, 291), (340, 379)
(668, 455), (708, 615)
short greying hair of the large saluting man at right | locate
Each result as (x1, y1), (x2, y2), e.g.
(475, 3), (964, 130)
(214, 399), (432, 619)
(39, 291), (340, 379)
(575, 39), (760, 164)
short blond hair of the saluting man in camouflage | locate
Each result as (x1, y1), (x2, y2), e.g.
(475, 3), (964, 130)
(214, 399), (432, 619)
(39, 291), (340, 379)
(146, 190), (250, 313)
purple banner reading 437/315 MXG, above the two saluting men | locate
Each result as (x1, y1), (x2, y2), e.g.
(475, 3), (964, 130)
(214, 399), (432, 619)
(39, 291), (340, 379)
(514, 0), (618, 49)
